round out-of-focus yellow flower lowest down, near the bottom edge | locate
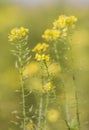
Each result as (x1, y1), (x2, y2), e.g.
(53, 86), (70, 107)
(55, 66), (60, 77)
(47, 109), (59, 122)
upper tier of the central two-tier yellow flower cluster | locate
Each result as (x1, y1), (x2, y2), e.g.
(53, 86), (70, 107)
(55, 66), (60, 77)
(32, 43), (49, 52)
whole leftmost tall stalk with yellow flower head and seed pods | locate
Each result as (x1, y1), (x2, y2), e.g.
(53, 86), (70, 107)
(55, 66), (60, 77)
(8, 27), (30, 130)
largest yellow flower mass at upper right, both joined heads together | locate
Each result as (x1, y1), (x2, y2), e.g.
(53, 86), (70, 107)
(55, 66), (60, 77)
(42, 15), (77, 41)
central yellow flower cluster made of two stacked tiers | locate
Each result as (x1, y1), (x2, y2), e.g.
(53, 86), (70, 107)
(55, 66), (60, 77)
(32, 43), (50, 62)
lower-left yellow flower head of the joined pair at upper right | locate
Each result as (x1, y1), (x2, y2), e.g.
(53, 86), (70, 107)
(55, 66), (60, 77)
(42, 29), (60, 41)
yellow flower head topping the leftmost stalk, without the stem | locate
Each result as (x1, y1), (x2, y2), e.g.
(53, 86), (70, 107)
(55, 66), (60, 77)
(8, 27), (29, 42)
